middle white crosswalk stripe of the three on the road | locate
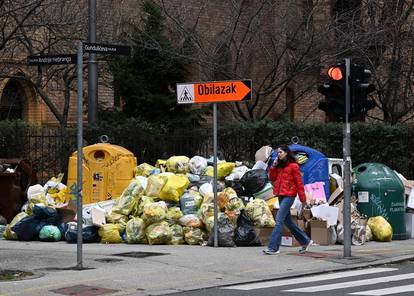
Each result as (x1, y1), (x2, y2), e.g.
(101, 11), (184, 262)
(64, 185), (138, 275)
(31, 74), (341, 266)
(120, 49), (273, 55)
(283, 273), (414, 293)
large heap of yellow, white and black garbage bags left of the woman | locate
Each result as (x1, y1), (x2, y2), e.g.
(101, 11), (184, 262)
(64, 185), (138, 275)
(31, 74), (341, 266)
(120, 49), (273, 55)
(4, 156), (275, 247)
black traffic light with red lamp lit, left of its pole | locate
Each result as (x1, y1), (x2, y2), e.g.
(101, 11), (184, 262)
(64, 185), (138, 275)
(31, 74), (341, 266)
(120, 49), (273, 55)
(318, 63), (346, 120)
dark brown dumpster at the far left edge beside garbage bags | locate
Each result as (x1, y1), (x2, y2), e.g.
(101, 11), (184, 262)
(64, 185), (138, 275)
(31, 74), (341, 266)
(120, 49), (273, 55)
(0, 158), (37, 223)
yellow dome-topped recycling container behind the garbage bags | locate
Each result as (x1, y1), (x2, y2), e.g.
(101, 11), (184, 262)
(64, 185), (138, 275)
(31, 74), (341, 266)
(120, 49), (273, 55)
(66, 143), (137, 204)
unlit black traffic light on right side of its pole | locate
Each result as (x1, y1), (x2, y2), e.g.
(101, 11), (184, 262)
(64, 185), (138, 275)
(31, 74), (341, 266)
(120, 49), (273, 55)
(350, 64), (376, 117)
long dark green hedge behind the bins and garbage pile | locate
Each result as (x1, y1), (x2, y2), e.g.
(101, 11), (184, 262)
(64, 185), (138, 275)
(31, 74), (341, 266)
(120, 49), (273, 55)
(0, 119), (414, 179)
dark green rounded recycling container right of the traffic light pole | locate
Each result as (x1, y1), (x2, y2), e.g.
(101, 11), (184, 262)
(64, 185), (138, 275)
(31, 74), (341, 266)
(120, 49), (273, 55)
(352, 163), (407, 240)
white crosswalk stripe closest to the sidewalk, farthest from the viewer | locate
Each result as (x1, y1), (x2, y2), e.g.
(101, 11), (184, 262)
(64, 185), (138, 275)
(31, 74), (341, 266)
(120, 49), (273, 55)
(222, 268), (398, 290)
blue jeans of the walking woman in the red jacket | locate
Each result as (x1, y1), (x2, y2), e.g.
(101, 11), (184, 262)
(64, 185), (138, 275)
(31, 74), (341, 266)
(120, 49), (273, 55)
(268, 197), (310, 251)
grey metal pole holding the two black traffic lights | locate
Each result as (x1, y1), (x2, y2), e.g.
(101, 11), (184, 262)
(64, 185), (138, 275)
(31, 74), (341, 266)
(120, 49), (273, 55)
(343, 59), (352, 257)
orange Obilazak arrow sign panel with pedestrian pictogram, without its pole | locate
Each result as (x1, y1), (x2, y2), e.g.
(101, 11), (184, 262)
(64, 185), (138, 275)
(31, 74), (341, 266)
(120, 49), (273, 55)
(177, 79), (252, 104)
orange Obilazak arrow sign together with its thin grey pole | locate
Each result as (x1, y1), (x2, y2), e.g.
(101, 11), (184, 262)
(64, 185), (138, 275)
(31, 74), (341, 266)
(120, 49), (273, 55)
(177, 79), (252, 247)
